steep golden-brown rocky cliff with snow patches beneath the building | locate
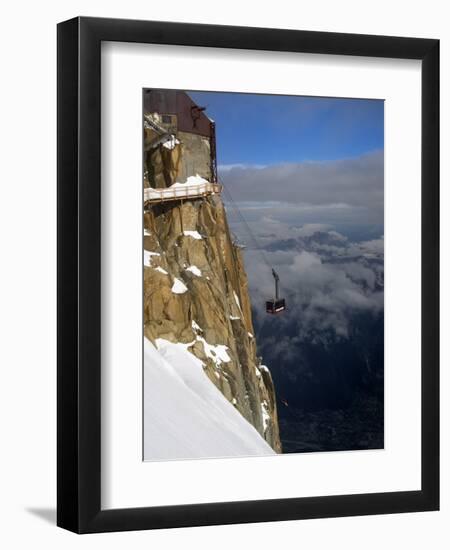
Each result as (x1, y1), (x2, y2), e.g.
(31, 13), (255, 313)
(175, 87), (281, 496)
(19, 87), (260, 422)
(144, 125), (281, 458)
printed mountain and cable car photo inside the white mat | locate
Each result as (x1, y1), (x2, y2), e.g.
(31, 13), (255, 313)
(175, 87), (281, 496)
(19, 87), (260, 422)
(143, 88), (384, 461)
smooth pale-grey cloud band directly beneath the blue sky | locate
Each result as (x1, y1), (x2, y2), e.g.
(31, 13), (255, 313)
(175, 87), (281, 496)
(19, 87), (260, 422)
(220, 151), (384, 232)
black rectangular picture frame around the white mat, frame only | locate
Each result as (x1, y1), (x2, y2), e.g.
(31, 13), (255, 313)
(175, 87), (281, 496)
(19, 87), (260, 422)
(57, 17), (439, 533)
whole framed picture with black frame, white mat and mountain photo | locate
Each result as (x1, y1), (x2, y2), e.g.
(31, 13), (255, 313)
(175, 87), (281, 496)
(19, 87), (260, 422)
(57, 17), (439, 533)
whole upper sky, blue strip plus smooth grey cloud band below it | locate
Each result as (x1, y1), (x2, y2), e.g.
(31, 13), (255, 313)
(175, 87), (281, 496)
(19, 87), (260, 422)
(189, 92), (384, 240)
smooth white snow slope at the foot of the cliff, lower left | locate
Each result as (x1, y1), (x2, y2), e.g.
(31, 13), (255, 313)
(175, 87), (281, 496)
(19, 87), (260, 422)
(144, 339), (275, 460)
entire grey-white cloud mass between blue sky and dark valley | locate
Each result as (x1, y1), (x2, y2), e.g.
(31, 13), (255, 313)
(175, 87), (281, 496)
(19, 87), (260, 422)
(222, 151), (384, 349)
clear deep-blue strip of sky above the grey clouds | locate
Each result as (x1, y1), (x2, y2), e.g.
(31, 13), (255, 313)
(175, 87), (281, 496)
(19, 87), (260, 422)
(189, 92), (384, 166)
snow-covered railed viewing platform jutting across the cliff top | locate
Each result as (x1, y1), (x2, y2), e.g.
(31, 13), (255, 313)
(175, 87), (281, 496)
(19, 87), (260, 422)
(144, 176), (222, 204)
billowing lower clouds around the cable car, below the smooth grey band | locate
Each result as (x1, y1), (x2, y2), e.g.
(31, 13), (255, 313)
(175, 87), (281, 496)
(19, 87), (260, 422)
(241, 224), (384, 342)
